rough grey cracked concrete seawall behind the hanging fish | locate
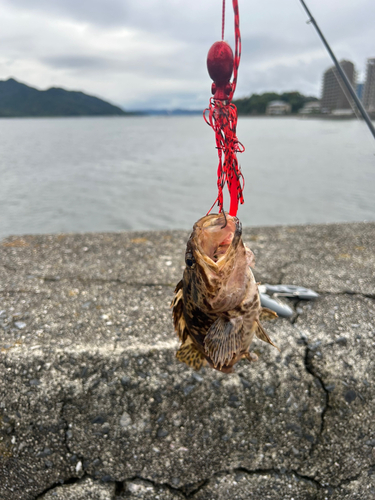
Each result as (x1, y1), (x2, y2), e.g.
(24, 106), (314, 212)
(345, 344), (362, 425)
(0, 223), (375, 500)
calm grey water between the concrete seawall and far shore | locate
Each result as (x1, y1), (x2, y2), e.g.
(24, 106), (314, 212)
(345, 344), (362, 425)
(0, 116), (375, 236)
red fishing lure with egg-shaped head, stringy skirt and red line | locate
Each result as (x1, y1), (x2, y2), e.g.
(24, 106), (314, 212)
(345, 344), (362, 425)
(203, 0), (245, 216)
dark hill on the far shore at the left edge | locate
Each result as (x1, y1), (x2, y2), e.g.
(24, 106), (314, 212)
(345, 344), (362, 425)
(0, 78), (127, 117)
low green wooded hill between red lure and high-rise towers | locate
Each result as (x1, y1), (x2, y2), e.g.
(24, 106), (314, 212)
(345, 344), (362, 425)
(233, 92), (318, 115)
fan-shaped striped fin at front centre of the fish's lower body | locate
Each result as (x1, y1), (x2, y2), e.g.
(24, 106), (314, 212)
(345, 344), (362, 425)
(204, 318), (243, 368)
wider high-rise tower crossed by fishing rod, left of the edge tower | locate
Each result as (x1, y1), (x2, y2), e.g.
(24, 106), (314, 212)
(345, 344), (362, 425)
(321, 60), (356, 113)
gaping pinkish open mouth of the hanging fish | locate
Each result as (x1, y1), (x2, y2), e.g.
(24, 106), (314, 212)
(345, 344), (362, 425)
(194, 213), (242, 264)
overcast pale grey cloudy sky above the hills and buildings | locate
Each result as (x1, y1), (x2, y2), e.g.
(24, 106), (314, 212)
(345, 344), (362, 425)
(0, 0), (375, 109)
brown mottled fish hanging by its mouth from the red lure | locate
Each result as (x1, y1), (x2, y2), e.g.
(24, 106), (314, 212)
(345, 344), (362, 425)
(172, 212), (277, 373)
